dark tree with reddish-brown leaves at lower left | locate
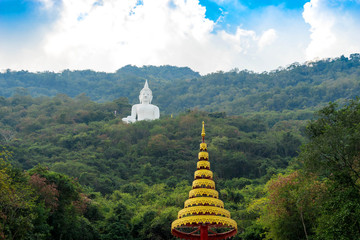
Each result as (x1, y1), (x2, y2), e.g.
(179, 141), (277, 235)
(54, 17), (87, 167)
(29, 166), (98, 240)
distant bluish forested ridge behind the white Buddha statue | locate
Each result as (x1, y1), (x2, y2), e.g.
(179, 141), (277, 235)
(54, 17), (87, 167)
(0, 54), (360, 115)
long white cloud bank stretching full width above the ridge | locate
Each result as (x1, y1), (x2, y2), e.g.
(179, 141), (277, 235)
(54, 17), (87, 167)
(0, 0), (360, 74)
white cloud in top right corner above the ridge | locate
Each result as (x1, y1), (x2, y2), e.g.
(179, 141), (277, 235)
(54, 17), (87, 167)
(303, 0), (360, 60)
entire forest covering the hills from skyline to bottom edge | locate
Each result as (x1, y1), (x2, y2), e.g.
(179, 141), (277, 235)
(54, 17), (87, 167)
(0, 54), (360, 240)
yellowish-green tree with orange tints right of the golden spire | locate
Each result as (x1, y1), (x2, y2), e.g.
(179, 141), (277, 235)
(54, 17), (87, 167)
(249, 171), (325, 240)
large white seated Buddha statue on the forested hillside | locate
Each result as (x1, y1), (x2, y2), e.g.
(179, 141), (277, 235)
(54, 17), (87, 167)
(122, 80), (160, 123)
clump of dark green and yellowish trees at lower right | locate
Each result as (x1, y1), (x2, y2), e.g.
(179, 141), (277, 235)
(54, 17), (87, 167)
(249, 99), (360, 240)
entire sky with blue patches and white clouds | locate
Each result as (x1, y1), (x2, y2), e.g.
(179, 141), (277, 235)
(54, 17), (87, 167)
(0, 0), (360, 74)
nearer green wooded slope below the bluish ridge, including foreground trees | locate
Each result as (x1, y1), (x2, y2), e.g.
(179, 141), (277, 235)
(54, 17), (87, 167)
(0, 95), (360, 240)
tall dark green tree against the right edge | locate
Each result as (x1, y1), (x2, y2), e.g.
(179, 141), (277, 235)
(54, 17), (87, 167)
(300, 98), (360, 239)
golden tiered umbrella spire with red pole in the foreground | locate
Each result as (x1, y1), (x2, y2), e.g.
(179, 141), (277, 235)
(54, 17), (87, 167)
(171, 122), (237, 240)
